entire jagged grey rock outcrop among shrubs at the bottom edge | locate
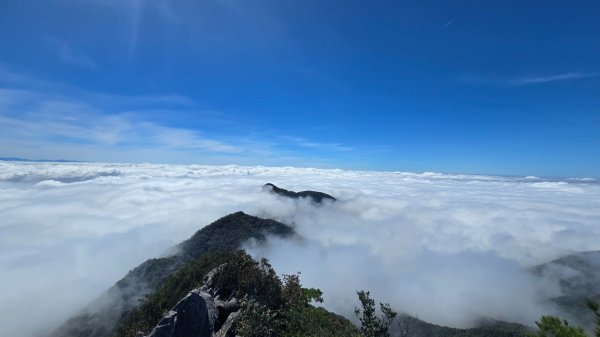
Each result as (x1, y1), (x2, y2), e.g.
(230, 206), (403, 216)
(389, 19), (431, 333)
(146, 265), (240, 337)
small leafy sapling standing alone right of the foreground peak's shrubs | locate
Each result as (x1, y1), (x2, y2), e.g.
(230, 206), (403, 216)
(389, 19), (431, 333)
(354, 290), (397, 337)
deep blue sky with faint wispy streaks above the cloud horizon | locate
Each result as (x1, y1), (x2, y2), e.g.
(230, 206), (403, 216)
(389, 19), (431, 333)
(0, 0), (600, 178)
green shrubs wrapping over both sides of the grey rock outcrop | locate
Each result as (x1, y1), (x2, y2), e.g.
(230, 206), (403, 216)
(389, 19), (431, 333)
(115, 251), (360, 337)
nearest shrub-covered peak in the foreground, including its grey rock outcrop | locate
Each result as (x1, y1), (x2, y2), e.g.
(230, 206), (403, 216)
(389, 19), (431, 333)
(115, 251), (358, 337)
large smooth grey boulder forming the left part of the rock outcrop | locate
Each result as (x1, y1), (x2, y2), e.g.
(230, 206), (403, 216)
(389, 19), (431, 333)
(148, 289), (219, 337)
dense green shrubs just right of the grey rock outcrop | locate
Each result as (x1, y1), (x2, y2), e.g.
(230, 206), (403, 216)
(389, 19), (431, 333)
(220, 252), (359, 337)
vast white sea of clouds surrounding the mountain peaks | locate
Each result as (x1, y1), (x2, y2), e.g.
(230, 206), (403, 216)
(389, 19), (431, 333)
(0, 162), (600, 337)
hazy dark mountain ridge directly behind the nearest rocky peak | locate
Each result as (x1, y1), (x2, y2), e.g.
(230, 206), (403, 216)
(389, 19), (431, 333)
(51, 212), (295, 337)
